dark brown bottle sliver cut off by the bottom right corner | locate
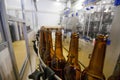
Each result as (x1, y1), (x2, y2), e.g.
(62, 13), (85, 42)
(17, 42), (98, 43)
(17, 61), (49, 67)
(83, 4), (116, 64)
(108, 55), (120, 80)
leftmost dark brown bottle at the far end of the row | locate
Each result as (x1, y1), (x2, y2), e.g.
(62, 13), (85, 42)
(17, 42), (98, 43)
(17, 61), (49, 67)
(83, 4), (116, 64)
(39, 29), (46, 59)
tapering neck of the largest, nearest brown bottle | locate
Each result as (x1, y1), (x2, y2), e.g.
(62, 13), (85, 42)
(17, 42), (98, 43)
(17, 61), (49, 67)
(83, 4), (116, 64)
(88, 35), (106, 74)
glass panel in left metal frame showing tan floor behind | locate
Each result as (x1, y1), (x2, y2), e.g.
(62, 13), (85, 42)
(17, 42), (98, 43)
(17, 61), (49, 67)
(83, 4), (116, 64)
(8, 21), (27, 73)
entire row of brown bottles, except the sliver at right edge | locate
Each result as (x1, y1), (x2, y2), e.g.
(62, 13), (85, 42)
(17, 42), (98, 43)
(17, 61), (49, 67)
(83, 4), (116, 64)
(39, 29), (115, 80)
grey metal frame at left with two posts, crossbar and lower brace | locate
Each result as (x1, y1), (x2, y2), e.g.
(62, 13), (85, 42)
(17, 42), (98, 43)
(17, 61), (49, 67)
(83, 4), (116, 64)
(0, 0), (31, 80)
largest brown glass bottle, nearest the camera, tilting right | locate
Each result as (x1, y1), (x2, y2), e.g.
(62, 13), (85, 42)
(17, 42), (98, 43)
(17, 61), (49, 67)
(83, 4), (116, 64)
(81, 35), (107, 80)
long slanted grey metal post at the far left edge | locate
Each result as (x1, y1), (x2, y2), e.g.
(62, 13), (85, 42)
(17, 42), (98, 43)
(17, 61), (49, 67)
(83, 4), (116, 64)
(0, 0), (20, 80)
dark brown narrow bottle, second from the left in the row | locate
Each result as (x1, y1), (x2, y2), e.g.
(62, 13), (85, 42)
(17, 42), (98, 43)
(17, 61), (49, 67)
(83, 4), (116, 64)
(43, 31), (51, 67)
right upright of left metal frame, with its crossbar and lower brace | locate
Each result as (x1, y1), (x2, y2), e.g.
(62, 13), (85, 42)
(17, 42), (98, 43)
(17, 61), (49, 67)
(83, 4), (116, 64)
(7, 0), (33, 79)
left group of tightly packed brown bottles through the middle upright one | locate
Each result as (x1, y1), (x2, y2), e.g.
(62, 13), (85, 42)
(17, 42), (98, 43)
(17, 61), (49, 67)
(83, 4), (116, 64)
(39, 28), (66, 80)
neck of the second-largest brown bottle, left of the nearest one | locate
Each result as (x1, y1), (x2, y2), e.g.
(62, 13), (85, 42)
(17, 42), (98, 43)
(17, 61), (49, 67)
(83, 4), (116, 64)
(67, 33), (78, 64)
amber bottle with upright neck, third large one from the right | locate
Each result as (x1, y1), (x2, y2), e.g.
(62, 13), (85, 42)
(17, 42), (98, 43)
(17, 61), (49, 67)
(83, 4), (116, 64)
(51, 31), (66, 80)
